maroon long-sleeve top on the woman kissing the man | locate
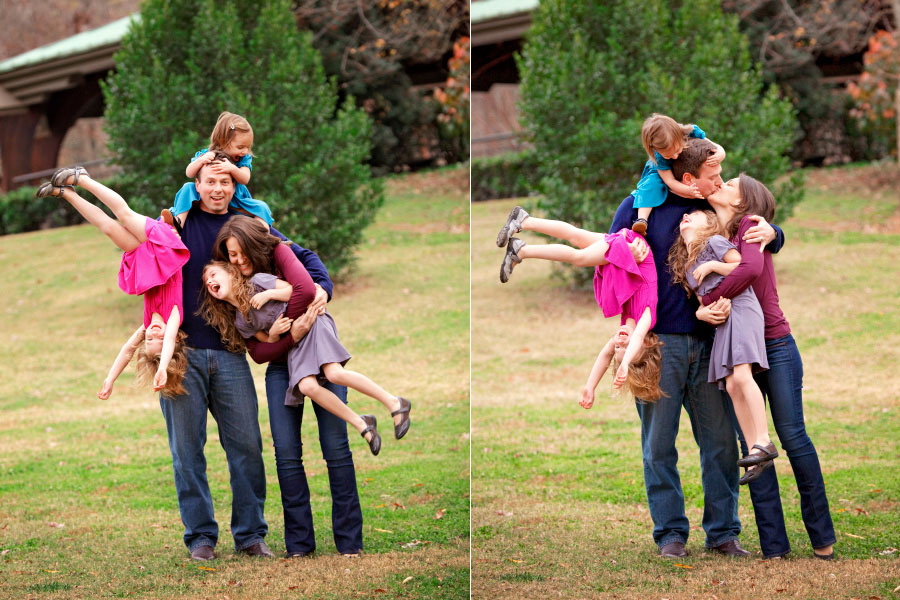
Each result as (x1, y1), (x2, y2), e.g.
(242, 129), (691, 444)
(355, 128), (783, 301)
(703, 217), (791, 340)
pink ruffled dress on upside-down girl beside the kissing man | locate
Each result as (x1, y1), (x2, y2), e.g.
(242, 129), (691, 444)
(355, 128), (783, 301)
(594, 229), (658, 328)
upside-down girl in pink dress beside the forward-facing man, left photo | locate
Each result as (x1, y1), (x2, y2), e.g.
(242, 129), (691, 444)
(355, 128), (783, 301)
(36, 167), (189, 400)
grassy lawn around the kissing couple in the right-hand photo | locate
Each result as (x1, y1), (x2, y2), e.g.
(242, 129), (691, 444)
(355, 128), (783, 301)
(472, 165), (900, 600)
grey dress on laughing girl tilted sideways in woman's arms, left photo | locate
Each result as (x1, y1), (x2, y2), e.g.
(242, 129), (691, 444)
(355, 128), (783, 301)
(234, 273), (350, 406)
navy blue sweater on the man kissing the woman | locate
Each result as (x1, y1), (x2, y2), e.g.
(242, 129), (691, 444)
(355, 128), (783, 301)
(610, 192), (784, 336)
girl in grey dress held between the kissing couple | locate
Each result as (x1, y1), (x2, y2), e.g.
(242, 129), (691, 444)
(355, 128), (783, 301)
(669, 210), (778, 483)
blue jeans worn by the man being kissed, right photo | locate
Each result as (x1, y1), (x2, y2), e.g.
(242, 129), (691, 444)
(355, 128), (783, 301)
(637, 334), (741, 547)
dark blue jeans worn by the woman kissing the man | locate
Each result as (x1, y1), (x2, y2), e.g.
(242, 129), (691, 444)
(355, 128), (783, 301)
(741, 334), (836, 557)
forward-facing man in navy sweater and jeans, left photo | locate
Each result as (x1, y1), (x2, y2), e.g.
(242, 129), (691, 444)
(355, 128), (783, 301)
(160, 157), (362, 560)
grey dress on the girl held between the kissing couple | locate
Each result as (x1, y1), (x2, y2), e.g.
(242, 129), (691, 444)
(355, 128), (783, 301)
(686, 235), (769, 390)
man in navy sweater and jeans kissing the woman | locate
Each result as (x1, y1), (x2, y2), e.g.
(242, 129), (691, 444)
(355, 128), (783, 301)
(610, 139), (784, 557)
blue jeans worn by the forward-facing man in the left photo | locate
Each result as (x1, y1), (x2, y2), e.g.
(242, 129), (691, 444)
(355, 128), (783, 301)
(159, 348), (269, 551)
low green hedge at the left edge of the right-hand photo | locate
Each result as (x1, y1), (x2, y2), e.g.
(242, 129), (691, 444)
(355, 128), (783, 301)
(470, 150), (538, 202)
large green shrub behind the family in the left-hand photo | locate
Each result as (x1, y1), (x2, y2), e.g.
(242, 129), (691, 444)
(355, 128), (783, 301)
(103, 0), (383, 273)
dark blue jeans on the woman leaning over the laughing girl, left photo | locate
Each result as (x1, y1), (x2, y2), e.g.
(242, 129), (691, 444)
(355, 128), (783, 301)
(266, 363), (363, 554)
